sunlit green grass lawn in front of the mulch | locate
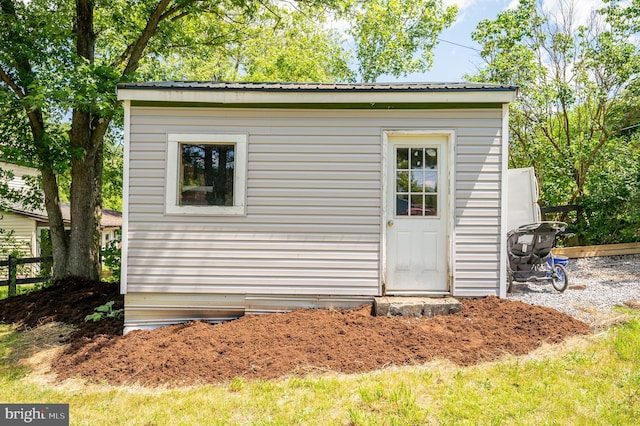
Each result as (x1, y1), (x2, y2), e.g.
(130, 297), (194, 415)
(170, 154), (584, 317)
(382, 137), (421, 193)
(0, 311), (640, 425)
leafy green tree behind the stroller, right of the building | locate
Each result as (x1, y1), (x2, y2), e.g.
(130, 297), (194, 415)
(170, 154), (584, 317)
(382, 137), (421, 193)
(472, 0), (640, 240)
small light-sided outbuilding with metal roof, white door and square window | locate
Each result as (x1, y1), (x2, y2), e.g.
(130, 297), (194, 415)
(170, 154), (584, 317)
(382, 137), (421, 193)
(118, 82), (516, 332)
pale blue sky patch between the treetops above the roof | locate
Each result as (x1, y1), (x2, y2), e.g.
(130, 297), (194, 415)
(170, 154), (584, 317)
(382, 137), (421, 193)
(378, 0), (602, 82)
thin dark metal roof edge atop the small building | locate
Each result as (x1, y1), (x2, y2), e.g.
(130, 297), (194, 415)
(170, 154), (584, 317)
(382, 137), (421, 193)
(118, 81), (518, 92)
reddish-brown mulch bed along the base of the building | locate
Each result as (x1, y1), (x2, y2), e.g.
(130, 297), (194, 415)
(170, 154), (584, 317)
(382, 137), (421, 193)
(0, 279), (590, 385)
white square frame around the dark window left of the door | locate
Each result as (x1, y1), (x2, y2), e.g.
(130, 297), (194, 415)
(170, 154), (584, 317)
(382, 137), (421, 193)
(165, 133), (248, 216)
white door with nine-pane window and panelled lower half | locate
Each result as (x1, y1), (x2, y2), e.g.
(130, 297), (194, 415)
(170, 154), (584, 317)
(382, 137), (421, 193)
(385, 134), (450, 294)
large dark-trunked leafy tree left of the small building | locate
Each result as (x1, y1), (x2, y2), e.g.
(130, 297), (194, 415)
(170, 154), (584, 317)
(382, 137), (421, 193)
(0, 0), (272, 279)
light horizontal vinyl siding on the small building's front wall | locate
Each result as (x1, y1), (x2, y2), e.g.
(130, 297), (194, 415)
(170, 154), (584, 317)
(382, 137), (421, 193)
(126, 106), (503, 324)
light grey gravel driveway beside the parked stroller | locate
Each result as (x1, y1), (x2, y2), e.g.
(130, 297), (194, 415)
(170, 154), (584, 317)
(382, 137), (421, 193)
(507, 255), (640, 326)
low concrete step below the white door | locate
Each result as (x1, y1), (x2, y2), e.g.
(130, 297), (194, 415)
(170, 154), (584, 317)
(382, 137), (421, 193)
(373, 296), (462, 318)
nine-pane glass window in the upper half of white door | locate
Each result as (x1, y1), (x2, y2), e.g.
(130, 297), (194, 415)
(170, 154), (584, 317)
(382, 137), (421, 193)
(395, 147), (438, 217)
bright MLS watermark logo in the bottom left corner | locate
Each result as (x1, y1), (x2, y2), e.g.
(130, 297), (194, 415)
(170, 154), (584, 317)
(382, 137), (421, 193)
(0, 404), (69, 426)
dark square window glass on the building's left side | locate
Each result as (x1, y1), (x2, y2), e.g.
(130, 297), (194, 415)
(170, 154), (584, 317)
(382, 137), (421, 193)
(178, 143), (235, 206)
